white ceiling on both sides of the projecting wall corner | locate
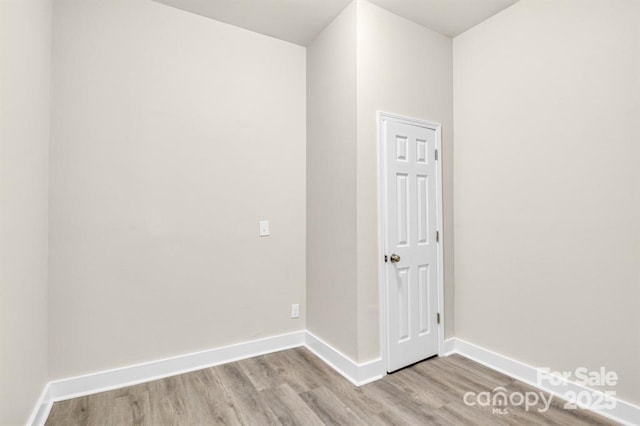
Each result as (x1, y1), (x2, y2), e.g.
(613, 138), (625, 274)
(156, 0), (518, 46)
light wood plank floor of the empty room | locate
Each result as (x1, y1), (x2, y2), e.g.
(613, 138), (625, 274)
(46, 348), (612, 426)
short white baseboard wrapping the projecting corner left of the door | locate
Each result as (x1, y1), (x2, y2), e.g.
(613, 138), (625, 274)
(305, 331), (386, 386)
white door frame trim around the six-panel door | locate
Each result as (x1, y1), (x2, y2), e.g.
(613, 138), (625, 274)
(376, 111), (445, 373)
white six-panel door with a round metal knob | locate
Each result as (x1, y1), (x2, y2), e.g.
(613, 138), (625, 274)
(381, 117), (439, 372)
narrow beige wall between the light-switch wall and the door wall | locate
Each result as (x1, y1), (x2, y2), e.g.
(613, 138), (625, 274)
(307, 2), (358, 359)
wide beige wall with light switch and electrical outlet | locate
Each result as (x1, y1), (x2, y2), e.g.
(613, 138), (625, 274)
(49, 0), (306, 379)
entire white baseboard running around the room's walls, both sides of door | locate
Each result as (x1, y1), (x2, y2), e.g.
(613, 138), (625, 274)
(33, 330), (640, 426)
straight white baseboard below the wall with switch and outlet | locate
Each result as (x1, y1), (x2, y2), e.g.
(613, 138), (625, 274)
(49, 330), (305, 402)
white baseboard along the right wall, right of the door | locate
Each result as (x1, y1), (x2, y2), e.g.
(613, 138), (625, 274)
(445, 338), (640, 425)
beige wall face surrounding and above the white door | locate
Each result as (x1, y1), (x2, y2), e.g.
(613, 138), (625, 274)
(357, 0), (454, 361)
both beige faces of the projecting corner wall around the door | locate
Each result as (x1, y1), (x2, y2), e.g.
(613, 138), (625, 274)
(307, 0), (453, 362)
